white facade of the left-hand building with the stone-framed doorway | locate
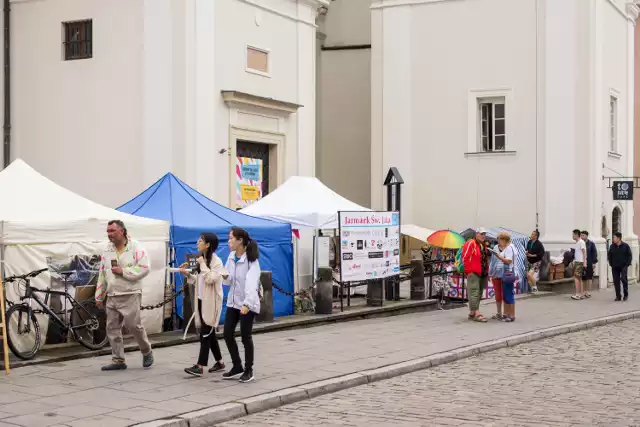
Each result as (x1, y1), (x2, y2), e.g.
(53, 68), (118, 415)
(5, 0), (328, 208)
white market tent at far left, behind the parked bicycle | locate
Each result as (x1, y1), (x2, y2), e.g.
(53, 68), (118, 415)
(0, 160), (169, 342)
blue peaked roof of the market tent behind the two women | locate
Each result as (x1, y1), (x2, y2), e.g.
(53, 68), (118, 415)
(118, 173), (291, 245)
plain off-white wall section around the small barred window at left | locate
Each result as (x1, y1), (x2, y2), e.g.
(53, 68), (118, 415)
(11, 0), (144, 206)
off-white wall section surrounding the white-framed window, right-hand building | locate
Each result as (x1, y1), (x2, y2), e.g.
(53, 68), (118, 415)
(371, 0), (536, 232)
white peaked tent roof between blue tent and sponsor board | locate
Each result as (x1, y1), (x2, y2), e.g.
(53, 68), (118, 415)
(242, 176), (371, 228)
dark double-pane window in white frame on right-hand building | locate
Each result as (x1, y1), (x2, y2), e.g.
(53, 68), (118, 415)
(478, 97), (507, 152)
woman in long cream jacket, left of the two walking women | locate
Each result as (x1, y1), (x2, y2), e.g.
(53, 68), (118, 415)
(181, 233), (228, 377)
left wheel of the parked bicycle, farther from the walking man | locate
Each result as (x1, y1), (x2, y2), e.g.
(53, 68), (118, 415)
(6, 304), (41, 360)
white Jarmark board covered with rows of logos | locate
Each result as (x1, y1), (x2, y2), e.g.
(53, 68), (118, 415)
(338, 212), (400, 282)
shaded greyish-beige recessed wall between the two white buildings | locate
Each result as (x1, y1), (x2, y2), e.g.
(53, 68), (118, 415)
(316, 0), (372, 206)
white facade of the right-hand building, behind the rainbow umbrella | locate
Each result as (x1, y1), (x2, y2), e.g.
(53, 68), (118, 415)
(371, 0), (638, 284)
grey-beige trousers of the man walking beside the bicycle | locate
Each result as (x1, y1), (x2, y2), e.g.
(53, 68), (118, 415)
(105, 294), (151, 363)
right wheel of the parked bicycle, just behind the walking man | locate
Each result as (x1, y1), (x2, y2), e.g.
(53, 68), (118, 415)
(71, 301), (107, 350)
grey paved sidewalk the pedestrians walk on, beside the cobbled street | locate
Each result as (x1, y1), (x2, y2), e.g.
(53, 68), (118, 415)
(0, 287), (640, 427)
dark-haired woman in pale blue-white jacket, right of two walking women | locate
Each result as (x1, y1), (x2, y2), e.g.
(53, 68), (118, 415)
(222, 227), (261, 383)
